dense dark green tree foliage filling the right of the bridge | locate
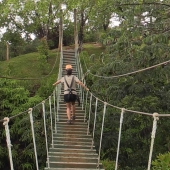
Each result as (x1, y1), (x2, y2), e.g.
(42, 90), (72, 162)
(83, 1), (170, 167)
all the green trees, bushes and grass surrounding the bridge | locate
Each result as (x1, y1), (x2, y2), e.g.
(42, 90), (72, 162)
(0, 0), (170, 170)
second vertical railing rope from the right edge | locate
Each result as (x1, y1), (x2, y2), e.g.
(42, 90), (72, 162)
(115, 108), (125, 170)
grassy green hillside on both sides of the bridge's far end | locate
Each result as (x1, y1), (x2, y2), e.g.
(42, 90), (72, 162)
(0, 43), (104, 95)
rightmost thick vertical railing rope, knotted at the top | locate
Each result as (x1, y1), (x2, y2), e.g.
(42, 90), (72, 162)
(147, 113), (159, 170)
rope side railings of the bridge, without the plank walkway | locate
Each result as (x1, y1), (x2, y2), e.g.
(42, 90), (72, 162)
(1, 48), (170, 170)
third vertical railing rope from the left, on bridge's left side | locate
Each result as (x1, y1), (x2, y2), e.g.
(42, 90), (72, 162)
(42, 101), (50, 168)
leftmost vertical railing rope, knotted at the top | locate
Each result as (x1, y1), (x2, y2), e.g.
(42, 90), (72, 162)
(3, 117), (14, 170)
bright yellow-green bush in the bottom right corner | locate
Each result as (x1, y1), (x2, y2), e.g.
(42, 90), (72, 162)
(152, 152), (170, 170)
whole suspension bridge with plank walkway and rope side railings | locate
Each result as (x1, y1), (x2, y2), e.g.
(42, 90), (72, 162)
(1, 8), (170, 170)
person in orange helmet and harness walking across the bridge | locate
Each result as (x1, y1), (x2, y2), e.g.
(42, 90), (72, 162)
(53, 65), (89, 124)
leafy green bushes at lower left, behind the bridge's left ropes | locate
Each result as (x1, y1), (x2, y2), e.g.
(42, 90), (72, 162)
(0, 79), (51, 170)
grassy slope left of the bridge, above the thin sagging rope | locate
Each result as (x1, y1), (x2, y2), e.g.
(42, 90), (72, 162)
(0, 50), (59, 78)
